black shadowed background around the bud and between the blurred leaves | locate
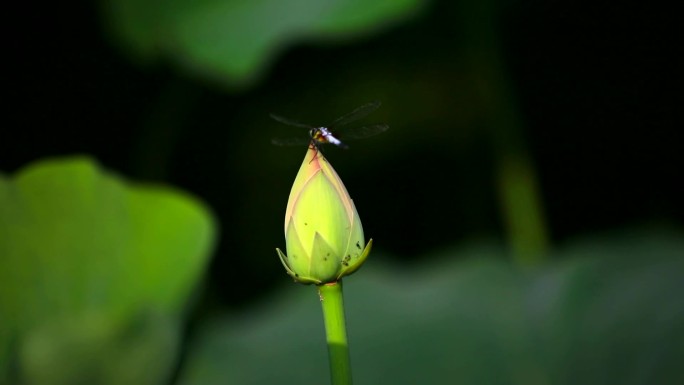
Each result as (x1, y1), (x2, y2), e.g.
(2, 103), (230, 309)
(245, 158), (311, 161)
(0, 1), (684, 306)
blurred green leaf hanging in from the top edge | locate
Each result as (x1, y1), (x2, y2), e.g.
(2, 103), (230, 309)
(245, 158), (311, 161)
(103, 0), (424, 85)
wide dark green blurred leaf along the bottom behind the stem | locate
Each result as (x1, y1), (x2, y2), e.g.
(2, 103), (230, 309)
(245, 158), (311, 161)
(181, 234), (684, 385)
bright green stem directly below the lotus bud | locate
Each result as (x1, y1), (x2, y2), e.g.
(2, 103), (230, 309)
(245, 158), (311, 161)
(318, 281), (352, 385)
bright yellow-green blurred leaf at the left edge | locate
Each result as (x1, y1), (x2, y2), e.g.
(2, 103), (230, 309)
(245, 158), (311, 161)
(0, 157), (215, 384)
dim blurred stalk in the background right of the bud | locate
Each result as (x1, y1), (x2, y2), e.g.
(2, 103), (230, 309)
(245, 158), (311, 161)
(454, 0), (550, 266)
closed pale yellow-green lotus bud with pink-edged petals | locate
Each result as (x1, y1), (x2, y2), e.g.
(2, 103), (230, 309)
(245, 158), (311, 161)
(276, 146), (373, 285)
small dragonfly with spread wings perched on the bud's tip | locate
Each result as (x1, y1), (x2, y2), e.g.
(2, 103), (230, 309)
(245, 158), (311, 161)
(271, 101), (389, 150)
